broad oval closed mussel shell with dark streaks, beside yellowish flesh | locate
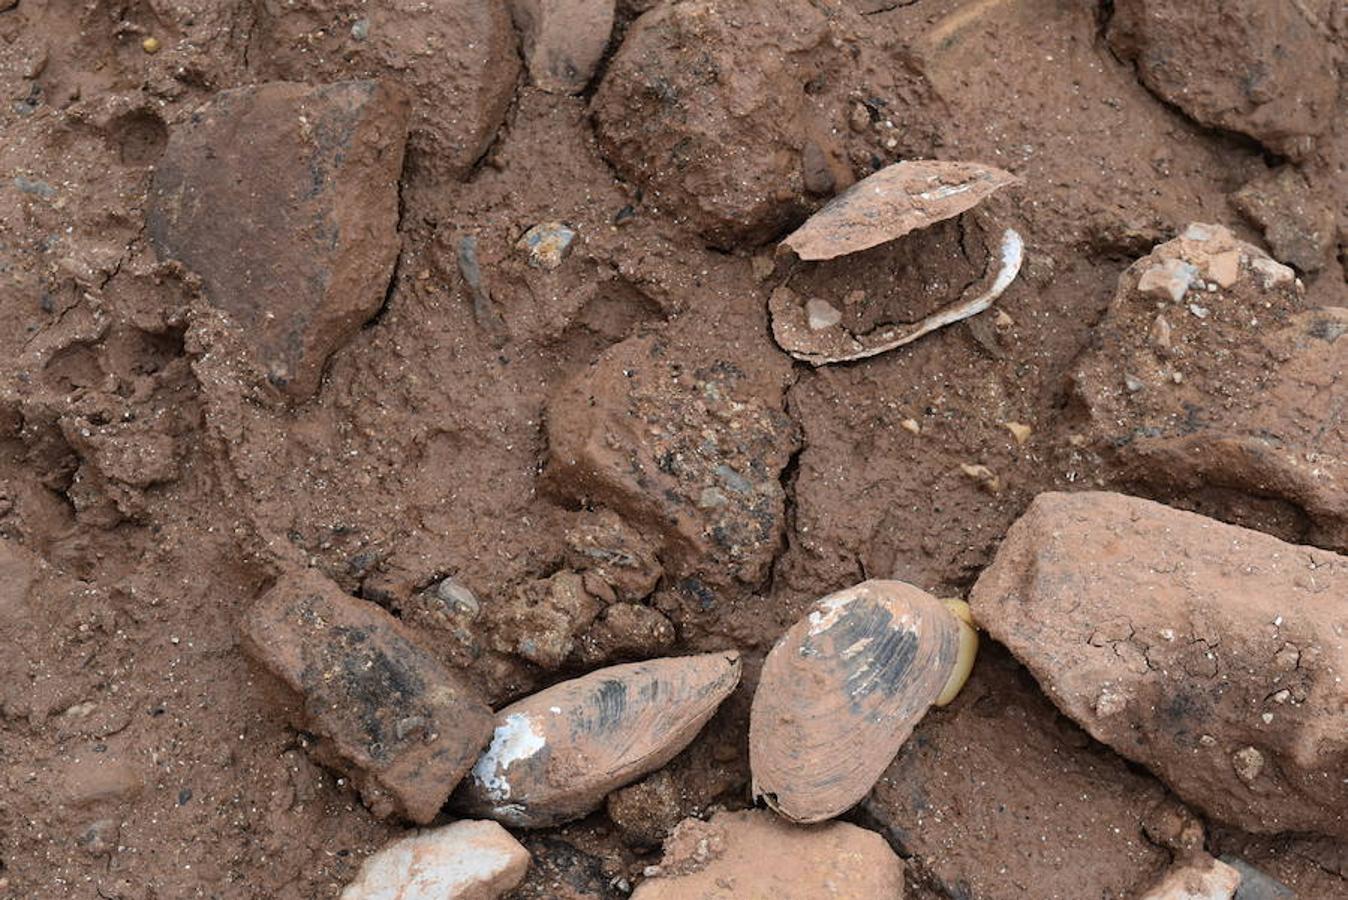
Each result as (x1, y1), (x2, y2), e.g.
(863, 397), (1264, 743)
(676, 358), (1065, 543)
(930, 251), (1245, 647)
(749, 581), (960, 823)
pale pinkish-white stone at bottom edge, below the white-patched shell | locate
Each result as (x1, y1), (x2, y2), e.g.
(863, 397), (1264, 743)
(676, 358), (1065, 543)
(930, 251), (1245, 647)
(341, 819), (528, 900)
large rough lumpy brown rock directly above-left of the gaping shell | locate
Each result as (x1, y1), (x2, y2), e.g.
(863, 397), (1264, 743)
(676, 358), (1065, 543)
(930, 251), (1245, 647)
(593, 0), (868, 247)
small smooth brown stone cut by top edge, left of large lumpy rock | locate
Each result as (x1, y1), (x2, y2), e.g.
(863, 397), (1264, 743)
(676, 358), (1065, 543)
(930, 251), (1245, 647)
(511, 0), (616, 94)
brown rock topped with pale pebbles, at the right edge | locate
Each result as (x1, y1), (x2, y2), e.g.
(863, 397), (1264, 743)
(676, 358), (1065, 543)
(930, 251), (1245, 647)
(1072, 225), (1348, 550)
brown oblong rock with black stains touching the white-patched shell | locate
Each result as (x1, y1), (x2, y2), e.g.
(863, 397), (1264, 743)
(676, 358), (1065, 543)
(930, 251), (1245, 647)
(243, 571), (492, 823)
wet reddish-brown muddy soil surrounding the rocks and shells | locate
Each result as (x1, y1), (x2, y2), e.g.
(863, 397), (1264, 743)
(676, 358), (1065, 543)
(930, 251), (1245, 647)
(0, 0), (1348, 900)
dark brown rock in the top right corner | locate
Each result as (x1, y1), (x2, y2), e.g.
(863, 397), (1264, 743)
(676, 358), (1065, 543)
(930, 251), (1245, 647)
(1108, 0), (1341, 158)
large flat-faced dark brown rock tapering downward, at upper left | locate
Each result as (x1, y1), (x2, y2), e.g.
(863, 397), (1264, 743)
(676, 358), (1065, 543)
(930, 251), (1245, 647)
(147, 81), (408, 399)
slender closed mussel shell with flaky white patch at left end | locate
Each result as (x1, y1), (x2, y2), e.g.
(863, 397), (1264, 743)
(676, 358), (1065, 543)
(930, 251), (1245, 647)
(454, 652), (740, 829)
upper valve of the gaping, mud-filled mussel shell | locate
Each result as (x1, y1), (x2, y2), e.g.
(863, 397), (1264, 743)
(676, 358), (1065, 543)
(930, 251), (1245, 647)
(782, 159), (1020, 260)
